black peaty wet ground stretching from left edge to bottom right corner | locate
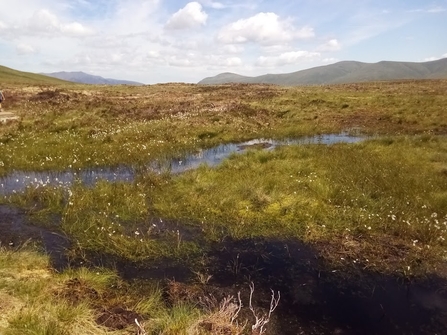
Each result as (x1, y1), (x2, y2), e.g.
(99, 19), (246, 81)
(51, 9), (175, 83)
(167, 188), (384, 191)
(0, 205), (447, 335)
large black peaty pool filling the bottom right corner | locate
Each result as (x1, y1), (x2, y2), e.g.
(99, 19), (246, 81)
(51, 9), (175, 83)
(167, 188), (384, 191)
(210, 239), (447, 335)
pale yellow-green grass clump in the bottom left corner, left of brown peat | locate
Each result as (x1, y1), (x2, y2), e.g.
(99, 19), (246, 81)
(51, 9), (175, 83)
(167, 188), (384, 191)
(0, 247), (104, 335)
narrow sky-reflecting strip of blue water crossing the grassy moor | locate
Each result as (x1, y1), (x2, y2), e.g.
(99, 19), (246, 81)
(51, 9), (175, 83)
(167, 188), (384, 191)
(0, 133), (365, 196)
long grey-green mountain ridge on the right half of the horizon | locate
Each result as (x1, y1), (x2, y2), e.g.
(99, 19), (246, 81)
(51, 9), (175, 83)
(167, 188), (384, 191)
(199, 58), (447, 86)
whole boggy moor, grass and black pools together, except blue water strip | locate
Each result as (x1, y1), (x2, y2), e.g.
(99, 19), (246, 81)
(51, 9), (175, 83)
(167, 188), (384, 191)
(0, 81), (447, 335)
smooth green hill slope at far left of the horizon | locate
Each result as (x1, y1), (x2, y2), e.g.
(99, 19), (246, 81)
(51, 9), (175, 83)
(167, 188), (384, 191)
(0, 65), (69, 85)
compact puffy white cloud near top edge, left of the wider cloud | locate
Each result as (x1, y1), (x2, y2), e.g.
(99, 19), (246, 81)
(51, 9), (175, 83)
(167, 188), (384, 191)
(165, 2), (208, 29)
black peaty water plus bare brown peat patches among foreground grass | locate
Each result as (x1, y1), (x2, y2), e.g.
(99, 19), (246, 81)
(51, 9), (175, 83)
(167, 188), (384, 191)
(0, 206), (447, 335)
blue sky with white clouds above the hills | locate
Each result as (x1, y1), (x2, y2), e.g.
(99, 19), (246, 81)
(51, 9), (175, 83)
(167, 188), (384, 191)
(0, 0), (447, 84)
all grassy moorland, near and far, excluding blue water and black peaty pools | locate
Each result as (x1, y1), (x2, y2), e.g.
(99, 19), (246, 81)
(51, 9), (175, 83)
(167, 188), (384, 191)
(0, 81), (447, 334)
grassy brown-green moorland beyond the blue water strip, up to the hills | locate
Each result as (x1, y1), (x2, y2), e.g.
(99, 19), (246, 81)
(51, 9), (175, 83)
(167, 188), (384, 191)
(0, 81), (447, 175)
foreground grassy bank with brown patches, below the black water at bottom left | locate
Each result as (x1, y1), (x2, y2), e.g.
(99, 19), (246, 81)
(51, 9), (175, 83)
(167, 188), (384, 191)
(0, 247), (248, 335)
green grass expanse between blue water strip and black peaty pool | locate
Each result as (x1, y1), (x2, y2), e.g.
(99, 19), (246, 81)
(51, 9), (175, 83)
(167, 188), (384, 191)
(5, 135), (447, 272)
